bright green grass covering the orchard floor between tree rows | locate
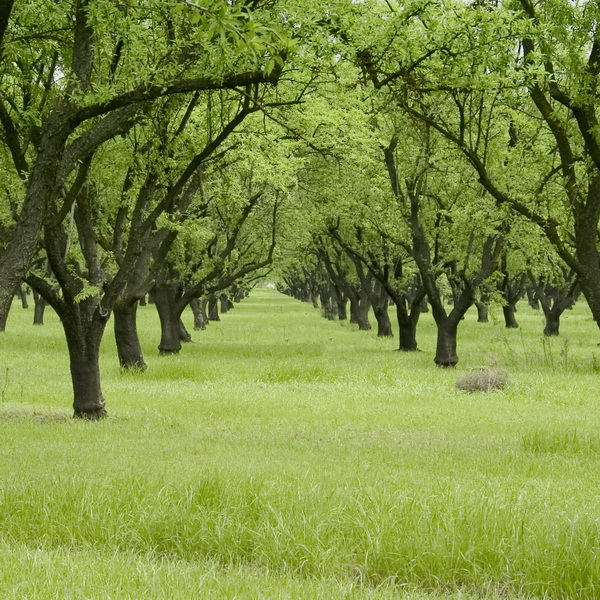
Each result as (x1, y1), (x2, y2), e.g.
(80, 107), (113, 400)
(0, 290), (600, 600)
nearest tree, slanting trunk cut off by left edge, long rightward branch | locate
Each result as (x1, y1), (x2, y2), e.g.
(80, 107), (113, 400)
(0, 0), (290, 329)
